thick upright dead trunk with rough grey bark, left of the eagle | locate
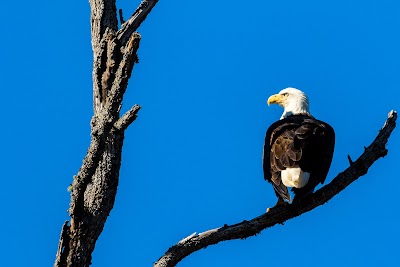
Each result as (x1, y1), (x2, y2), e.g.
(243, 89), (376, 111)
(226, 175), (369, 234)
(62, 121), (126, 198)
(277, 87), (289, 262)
(54, 0), (158, 267)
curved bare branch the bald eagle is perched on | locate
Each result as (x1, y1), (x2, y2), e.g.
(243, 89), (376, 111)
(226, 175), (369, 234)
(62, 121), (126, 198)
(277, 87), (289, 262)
(153, 111), (397, 267)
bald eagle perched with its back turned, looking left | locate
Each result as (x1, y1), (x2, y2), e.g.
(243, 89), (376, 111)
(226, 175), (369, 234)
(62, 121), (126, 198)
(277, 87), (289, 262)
(263, 88), (335, 206)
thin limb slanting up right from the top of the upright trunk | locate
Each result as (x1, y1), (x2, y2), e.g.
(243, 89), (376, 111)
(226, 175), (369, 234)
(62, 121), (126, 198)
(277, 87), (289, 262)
(118, 0), (158, 45)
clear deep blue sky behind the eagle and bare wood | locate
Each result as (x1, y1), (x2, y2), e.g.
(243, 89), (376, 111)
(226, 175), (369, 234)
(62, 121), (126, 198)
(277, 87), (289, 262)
(0, 0), (400, 267)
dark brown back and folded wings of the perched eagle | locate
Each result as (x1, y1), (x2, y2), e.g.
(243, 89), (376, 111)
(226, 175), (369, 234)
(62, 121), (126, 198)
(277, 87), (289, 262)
(263, 115), (335, 201)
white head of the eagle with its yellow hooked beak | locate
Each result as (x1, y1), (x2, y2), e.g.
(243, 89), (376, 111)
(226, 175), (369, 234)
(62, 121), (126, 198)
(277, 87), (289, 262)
(267, 87), (310, 119)
